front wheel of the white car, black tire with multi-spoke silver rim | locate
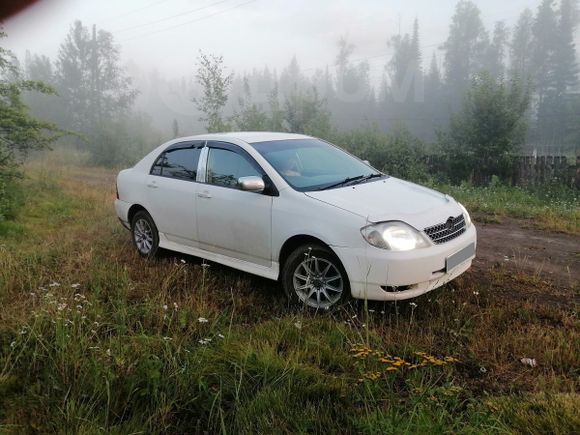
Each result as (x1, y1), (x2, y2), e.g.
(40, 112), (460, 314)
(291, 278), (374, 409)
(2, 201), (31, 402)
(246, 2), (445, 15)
(281, 244), (350, 311)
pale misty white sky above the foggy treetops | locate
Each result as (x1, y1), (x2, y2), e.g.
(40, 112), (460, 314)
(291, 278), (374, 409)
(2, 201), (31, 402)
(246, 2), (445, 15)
(3, 0), (540, 80)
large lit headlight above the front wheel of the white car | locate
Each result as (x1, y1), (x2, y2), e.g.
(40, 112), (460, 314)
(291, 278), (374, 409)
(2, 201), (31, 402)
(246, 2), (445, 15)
(360, 222), (429, 251)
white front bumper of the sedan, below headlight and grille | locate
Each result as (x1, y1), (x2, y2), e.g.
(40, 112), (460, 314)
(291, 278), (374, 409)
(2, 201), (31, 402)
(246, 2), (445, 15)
(334, 225), (477, 301)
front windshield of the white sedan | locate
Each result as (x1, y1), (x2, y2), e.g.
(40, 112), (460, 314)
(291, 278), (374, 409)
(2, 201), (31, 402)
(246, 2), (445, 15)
(251, 139), (382, 192)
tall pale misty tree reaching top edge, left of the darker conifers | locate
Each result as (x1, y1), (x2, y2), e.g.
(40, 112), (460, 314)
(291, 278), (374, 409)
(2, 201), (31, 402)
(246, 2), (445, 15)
(442, 0), (488, 106)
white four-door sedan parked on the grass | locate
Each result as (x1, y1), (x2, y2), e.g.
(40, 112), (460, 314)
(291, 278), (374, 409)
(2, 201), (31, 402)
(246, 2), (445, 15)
(115, 132), (476, 309)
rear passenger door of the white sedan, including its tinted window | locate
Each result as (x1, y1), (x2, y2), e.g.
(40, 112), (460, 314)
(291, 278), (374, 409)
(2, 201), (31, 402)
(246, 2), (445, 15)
(147, 141), (204, 246)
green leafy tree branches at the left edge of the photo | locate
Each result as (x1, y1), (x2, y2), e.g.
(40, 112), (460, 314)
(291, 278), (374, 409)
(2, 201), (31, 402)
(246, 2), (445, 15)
(0, 29), (64, 219)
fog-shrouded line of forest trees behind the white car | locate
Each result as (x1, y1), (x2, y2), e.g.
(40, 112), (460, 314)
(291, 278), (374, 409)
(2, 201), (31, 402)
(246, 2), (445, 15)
(3, 0), (580, 183)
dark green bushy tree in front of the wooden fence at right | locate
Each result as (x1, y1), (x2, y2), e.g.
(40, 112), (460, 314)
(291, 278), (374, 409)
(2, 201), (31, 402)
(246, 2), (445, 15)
(439, 72), (529, 184)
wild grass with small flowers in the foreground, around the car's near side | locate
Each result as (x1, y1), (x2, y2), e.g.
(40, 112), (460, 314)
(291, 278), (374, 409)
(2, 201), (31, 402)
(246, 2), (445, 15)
(0, 165), (580, 434)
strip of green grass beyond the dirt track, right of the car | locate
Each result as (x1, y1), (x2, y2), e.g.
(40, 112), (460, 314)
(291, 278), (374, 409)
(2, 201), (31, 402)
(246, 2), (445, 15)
(432, 183), (580, 234)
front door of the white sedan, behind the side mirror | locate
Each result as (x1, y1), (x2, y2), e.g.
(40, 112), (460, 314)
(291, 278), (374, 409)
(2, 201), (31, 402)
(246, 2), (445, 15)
(196, 142), (272, 267)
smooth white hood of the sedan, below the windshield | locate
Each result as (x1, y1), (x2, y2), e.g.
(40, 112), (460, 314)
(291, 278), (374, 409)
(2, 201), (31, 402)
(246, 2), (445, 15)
(305, 177), (461, 230)
